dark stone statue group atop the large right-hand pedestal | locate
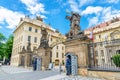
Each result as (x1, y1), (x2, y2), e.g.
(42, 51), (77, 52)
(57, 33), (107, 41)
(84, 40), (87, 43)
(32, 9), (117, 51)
(66, 12), (84, 39)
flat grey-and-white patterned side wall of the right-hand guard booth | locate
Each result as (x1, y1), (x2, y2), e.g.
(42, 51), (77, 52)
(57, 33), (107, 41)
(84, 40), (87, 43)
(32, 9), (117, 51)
(71, 55), (78, 75)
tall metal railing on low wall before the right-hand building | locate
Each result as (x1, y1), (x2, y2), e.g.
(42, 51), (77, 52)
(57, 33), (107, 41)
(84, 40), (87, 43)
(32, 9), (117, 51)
(88, 40), (120, 72)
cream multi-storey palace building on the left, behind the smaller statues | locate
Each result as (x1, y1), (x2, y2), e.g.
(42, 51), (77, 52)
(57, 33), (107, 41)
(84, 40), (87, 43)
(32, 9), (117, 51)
(11, 16), (66, 67)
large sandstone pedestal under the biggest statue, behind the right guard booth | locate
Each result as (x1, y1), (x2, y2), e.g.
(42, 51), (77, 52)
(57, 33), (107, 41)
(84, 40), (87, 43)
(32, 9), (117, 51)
(65, 38), (89, 75)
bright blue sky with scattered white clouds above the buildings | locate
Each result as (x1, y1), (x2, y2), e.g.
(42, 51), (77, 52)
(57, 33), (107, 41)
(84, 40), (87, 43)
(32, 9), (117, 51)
(0, 0), (120, 37)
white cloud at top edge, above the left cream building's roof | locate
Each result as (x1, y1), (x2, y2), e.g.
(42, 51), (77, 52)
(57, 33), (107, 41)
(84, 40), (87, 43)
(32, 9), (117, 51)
(21, 0), (47, 15)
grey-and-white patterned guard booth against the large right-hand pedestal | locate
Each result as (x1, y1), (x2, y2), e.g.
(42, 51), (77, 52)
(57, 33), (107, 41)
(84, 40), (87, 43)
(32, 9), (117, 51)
(65, 53), (78, 76)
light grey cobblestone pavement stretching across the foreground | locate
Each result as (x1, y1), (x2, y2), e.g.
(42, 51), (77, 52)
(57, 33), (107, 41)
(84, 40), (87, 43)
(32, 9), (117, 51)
(0, 66), (104, 80)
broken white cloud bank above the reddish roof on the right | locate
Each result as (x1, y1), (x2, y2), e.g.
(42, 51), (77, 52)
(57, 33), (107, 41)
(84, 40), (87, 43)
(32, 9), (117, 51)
(82, 6), (120, 27)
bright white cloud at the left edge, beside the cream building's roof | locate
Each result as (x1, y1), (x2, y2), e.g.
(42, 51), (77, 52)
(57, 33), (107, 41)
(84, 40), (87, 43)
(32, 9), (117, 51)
(0, 6), (24, 29)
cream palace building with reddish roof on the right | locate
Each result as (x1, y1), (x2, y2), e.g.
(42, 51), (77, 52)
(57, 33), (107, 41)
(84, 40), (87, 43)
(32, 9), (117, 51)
(85, 17), (120, 66)
